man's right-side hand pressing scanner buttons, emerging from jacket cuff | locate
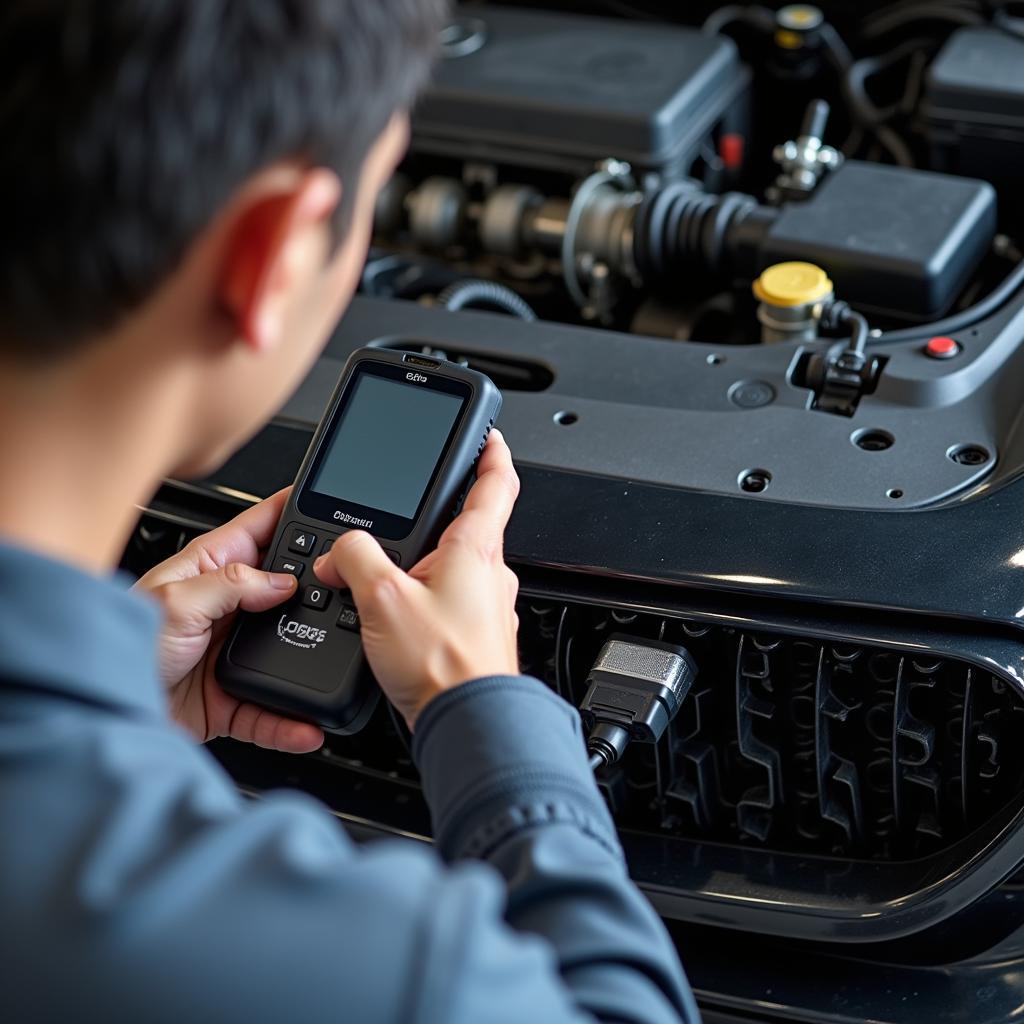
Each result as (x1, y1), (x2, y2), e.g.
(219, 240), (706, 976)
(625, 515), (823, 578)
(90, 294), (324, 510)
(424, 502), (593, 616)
(313, 430), (519, 728)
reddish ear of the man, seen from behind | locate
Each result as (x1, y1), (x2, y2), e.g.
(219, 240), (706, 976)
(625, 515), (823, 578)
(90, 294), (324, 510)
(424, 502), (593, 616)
(219, 168), (341, 351)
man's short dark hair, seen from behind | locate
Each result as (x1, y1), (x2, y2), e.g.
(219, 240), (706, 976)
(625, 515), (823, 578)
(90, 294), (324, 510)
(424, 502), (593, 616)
(0, 0), (446, 357)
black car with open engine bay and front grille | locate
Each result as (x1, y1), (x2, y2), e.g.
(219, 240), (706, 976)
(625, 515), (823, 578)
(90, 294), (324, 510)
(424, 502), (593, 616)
(124, 0), (1024, 1021)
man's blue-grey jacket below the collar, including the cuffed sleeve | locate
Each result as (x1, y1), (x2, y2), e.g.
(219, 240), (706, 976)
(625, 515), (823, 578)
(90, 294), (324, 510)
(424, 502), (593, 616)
(0, 679), (696, 1024)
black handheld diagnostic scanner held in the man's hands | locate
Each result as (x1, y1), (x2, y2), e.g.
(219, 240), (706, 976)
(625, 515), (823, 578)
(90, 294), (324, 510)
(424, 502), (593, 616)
(217, 348), (502, 733)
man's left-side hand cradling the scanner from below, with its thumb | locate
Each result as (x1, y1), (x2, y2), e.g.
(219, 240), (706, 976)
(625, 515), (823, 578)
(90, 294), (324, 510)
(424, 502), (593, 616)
(135, 489), (324, 754)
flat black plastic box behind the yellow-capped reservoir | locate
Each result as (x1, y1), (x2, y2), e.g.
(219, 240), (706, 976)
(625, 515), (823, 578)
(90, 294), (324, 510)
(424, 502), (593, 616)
(758, 160), (995, 321)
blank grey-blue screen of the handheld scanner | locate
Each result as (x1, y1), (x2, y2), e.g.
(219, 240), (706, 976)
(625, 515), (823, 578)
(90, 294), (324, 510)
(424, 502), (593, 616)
(312, 374), (464, 519)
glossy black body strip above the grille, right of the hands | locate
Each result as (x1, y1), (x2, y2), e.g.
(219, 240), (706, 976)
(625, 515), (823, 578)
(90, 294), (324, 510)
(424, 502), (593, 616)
(507, 466), (1024, 638)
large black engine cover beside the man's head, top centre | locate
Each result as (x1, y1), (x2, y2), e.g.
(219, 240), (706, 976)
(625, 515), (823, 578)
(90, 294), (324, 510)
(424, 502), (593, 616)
(413, 6), (749, 170)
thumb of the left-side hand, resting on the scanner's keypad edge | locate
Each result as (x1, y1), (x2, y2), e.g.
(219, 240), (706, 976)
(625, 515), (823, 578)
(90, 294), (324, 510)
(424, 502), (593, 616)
(158, 562), (297, 636)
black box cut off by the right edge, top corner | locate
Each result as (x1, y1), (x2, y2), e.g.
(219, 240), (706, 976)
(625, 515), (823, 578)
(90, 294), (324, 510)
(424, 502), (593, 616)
(924, 28), (1024, 197)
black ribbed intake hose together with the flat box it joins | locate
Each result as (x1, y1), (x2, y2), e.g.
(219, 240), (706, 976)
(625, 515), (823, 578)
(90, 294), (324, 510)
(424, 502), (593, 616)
(633, 160), (995, 321)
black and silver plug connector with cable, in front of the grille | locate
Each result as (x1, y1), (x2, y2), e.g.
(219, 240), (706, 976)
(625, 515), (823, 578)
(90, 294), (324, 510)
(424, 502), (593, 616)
(580, 634), (697, 771)
